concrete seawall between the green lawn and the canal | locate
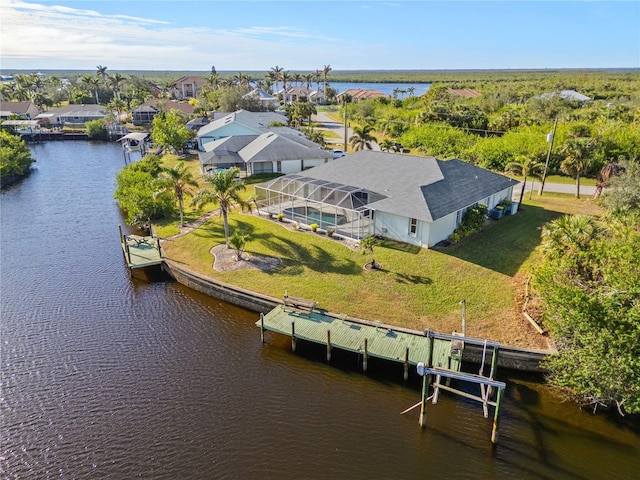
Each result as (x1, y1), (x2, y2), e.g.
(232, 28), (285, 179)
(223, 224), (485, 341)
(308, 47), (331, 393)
(163, 258), (551, 372)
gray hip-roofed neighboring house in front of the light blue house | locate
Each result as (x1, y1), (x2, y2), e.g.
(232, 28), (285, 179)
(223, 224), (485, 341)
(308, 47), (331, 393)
(198, 127), (333, 175)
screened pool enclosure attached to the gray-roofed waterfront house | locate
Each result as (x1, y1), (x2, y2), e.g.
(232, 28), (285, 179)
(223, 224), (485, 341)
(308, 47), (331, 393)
(255, 174), (385, 240)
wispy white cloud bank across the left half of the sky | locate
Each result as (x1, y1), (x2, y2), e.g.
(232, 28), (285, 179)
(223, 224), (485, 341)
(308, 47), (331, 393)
(0, 0), (338, 70)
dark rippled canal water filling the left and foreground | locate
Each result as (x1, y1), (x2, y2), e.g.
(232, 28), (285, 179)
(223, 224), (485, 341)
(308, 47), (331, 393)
(0, 142), (640, 479)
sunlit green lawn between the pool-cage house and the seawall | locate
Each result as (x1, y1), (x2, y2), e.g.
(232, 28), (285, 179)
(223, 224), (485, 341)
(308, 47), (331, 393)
(163, 194), (599, 347)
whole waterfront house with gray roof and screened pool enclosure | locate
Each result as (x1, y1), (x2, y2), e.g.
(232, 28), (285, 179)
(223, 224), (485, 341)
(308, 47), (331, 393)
(255, 150), (517, 248)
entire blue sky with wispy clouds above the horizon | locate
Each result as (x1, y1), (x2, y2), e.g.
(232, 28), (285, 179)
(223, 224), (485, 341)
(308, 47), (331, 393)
(0, 0), (640, 71)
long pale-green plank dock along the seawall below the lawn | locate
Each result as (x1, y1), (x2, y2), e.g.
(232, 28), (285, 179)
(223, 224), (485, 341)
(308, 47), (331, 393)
(256, 305), (463, 377)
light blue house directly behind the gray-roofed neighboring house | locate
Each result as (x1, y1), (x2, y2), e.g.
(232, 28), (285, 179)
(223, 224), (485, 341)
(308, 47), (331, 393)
(196, 110), (288, 152)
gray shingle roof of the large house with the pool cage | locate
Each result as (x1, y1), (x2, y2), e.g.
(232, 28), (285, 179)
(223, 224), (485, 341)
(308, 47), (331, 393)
(296, 150), (517, 222)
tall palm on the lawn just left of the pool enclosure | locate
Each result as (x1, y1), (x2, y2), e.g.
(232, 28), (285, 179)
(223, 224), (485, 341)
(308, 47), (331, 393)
(191, 168), (251, 248)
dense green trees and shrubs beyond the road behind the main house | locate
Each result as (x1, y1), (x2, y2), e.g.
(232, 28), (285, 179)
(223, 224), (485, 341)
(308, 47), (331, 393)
(341, 74), (640, 187)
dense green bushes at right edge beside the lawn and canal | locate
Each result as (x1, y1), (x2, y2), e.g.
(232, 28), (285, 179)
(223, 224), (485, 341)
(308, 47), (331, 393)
(535, 162), (640, 414)
